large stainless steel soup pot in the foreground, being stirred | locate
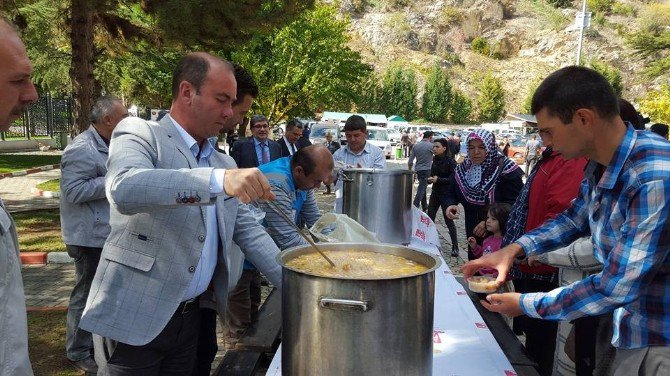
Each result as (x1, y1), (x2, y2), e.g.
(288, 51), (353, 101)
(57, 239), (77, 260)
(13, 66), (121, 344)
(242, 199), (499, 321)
(277, 243), (441, 376)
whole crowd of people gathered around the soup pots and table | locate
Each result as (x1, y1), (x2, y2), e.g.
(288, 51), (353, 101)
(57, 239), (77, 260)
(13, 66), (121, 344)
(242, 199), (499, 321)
(0, 13), (670, 375)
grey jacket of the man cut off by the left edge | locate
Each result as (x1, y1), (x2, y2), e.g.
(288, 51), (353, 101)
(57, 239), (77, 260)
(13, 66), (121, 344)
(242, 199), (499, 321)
(0, 200), (33, 376)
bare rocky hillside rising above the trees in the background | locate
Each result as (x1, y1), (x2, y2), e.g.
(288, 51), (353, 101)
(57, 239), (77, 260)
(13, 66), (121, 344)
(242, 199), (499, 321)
(339, 0), (667, 112)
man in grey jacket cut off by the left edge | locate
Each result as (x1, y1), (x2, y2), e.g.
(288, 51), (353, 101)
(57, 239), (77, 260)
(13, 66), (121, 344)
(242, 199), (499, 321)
(0, 18), (37, 375)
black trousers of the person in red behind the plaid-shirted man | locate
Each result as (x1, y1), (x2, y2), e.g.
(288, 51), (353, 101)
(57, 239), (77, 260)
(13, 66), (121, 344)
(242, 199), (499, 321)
(513, 279), (558, 376)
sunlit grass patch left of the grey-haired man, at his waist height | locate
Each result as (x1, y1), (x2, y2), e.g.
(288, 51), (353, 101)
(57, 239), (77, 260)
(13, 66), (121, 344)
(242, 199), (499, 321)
(12, 209), (65, 252)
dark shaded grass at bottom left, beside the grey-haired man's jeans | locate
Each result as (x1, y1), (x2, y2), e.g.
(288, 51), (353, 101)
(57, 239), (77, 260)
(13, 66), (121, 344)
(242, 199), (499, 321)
(28, 311), (84, 376)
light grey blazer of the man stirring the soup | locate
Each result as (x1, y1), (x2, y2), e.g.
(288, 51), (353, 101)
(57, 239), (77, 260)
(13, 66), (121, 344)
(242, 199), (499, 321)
(80, 116), (281, 346)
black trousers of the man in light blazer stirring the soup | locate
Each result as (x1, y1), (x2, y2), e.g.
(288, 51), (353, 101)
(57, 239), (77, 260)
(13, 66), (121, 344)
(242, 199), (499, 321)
(93, 307), (200, 376)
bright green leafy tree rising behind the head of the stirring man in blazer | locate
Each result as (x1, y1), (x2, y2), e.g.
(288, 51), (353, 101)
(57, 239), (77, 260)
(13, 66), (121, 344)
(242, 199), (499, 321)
(231, 5), (371, 123)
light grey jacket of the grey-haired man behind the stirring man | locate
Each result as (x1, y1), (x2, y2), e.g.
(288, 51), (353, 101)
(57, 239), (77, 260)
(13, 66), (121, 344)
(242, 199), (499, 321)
(60, 126), (110, 248)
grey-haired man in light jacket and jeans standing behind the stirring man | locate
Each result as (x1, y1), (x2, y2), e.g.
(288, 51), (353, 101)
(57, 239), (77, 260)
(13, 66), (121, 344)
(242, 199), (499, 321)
(60, 97), (128, 373)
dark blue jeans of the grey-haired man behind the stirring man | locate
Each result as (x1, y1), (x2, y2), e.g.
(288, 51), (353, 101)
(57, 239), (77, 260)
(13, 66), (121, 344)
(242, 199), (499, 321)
(65, 245), (102, 362)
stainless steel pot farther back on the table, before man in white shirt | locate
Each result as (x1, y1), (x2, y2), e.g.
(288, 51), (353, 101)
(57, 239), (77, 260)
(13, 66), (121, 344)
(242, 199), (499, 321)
(342, 168), (414, 244)
